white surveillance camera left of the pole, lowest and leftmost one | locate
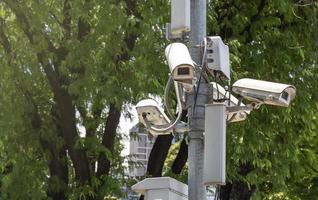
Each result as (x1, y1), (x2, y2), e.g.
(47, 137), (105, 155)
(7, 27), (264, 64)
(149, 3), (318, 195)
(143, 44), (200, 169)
(136, 99), (170, 135)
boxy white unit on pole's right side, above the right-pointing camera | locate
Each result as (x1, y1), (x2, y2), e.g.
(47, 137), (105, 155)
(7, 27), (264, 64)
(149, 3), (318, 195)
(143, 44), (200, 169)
(206, 36), (231, 80)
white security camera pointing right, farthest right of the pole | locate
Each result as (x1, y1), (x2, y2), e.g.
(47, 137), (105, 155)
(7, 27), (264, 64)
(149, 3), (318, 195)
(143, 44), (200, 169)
(232, 78), (296, 107)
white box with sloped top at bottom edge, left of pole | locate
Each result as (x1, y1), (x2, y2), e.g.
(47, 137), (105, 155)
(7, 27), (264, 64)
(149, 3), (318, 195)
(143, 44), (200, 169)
(131, 177), (188, 200)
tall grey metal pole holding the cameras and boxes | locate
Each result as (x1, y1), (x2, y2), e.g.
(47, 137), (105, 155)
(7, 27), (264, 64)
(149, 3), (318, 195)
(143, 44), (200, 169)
(187, 0), (208, 200)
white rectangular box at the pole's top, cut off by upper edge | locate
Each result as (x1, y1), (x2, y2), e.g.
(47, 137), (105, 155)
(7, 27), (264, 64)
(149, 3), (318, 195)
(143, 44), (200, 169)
(171, 0), (190, 36)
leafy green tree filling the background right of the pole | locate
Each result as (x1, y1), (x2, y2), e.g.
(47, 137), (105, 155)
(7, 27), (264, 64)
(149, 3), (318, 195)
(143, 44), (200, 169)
(144, 0), (318, 200)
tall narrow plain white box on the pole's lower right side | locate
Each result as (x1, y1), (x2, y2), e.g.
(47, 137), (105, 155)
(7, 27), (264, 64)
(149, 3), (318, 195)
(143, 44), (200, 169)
(203, 103), (226, 185)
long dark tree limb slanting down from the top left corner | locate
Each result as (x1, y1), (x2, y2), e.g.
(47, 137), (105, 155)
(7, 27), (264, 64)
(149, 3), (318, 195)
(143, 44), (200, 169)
(5, 0), (90, 185)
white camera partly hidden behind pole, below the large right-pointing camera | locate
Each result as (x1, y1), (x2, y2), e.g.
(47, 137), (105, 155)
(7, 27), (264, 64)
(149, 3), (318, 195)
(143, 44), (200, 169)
(210, 82), (250, 122)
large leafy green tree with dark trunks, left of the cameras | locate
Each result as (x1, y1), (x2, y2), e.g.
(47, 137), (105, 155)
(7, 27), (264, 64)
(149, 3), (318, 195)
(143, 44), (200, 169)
(0, 0), (167, 199)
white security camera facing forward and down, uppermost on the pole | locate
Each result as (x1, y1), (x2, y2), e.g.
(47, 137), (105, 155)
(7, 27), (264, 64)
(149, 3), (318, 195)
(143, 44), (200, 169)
(165, 43), (194, 91)
